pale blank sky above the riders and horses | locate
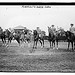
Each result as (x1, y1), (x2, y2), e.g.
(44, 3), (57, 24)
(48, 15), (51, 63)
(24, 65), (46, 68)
(0, 6), (75, 34)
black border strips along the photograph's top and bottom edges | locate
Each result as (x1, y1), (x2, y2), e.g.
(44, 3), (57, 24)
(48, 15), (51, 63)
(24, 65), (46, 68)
(0, 2), (75, 73)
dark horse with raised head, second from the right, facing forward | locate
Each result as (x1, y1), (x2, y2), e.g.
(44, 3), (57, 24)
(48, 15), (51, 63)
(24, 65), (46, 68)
(48, 27), (56, 48)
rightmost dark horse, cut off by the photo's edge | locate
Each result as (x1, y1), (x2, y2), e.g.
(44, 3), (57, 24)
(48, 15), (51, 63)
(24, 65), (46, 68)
(66, 31), (75, 51)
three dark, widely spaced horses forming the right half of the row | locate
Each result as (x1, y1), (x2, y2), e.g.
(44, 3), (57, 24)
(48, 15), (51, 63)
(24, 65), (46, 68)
(33, 28), (75, 51)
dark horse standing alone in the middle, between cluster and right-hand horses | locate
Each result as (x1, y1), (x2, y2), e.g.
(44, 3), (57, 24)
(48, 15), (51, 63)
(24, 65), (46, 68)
(33, 30), (44, 48)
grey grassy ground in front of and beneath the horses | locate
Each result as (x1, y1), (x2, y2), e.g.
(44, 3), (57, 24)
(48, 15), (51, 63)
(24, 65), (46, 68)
(0, 41), (75, 72)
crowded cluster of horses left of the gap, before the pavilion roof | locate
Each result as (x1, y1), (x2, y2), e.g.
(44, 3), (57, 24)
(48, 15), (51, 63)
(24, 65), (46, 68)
(0, 29), (30, 46)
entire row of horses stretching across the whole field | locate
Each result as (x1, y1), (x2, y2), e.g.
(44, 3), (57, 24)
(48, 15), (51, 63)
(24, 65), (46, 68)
(0, 29), (75, 51)
